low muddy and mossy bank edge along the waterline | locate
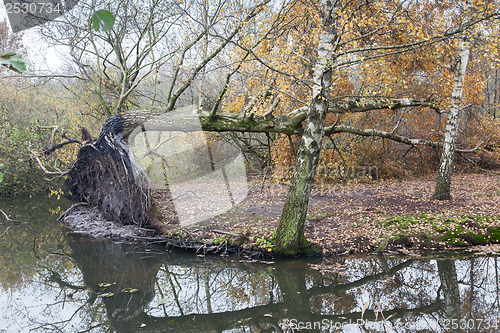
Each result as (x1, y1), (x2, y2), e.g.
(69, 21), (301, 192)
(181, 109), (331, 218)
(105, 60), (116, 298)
(58, 205), (500, 259)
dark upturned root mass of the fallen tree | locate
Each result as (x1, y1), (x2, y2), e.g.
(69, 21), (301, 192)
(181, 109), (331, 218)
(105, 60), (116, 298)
(66, 115), (150, 226)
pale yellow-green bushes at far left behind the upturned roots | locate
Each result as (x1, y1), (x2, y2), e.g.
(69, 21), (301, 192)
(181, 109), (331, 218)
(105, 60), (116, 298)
(0, 80), (100, 169)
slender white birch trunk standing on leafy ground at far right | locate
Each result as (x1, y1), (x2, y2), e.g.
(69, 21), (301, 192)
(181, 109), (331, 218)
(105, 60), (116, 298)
(432, 39), (470, 200)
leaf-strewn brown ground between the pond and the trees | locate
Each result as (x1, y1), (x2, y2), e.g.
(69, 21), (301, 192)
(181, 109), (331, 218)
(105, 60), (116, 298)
(154, 174), (500, 255)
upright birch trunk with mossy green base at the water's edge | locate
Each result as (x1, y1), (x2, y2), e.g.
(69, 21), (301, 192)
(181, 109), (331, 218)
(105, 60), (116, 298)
(274, 0), (337, 254)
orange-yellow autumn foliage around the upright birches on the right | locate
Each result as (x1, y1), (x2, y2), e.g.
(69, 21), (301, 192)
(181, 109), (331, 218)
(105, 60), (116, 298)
(228, 0), (500, 181)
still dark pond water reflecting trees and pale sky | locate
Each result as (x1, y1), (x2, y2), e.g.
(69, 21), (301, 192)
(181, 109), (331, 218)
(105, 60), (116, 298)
(0, 198), (500, 333)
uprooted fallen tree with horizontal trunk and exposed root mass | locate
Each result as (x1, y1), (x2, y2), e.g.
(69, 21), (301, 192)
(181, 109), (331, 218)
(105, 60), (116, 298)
(54, 93), (477, 230)
